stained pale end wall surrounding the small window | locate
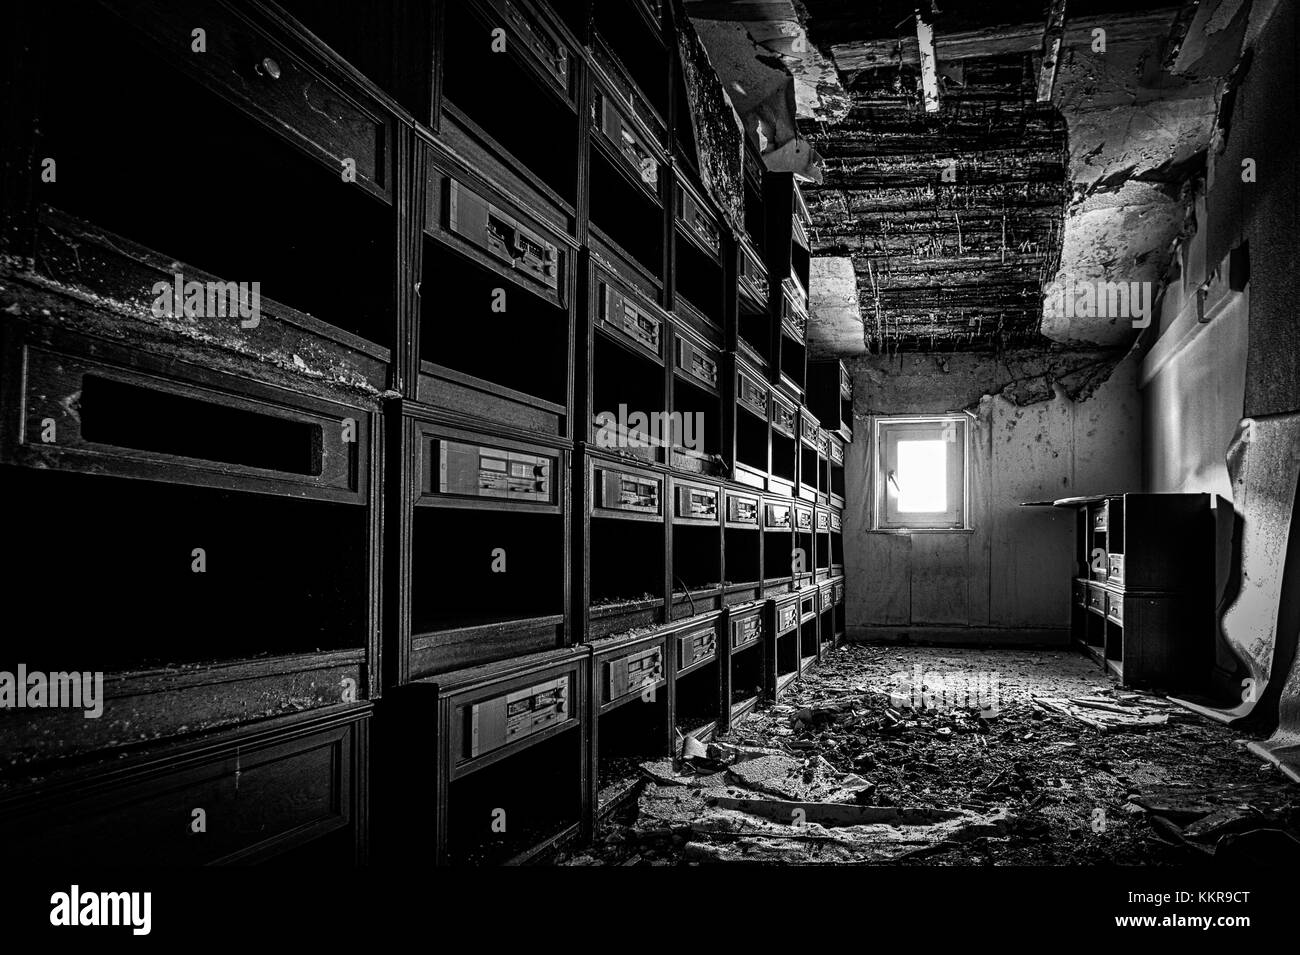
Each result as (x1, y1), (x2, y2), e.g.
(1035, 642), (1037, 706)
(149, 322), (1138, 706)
(845, 355), (1141, 643)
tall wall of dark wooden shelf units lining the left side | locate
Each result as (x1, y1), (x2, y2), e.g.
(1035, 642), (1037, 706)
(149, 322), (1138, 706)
(0, 0), (853, 864)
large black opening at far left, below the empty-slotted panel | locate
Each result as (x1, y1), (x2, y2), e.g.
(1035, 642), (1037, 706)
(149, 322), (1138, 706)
(8, 468), (368, 672)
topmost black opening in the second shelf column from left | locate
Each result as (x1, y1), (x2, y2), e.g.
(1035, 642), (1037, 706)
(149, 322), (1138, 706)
(442, 3), (577, 205)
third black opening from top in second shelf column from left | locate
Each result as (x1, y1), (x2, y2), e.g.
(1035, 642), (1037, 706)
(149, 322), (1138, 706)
(411, 507), (564, 641)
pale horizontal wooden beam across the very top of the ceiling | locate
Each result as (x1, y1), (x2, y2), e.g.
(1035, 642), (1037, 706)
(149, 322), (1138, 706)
(831, 6), (1182, 74)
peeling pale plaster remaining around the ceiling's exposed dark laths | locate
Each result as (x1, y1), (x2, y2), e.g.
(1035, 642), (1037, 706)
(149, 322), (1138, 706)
(688, 0), (1258, 355)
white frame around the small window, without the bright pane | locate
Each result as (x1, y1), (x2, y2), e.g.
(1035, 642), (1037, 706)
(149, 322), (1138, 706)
(872, 412), (971, 534)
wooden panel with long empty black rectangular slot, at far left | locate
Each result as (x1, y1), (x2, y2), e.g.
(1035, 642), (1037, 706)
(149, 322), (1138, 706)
(8, 338), (369, 502)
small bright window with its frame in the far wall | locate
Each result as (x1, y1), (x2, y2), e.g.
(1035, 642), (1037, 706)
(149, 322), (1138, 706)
(875, 414), (967, 530)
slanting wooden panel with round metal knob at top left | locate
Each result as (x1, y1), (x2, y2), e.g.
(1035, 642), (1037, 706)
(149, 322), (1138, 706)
(109, 0), (391, 194)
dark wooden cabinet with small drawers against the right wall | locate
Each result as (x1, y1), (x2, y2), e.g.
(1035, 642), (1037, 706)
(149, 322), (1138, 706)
(1056, 494), (1214, 691)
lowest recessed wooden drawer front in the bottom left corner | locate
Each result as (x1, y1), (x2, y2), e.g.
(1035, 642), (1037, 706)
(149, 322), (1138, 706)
(0, 720), (368, 865)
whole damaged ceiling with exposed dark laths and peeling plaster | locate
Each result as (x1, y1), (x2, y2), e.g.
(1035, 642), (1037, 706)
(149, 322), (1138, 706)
(686, 0), (1258, 356)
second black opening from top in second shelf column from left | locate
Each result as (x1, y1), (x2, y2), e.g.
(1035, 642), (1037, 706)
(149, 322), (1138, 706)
(420, 235), (569, 405)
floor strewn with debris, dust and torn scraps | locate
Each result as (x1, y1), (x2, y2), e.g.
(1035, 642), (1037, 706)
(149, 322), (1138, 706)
(558, 646), (1300, 865)
